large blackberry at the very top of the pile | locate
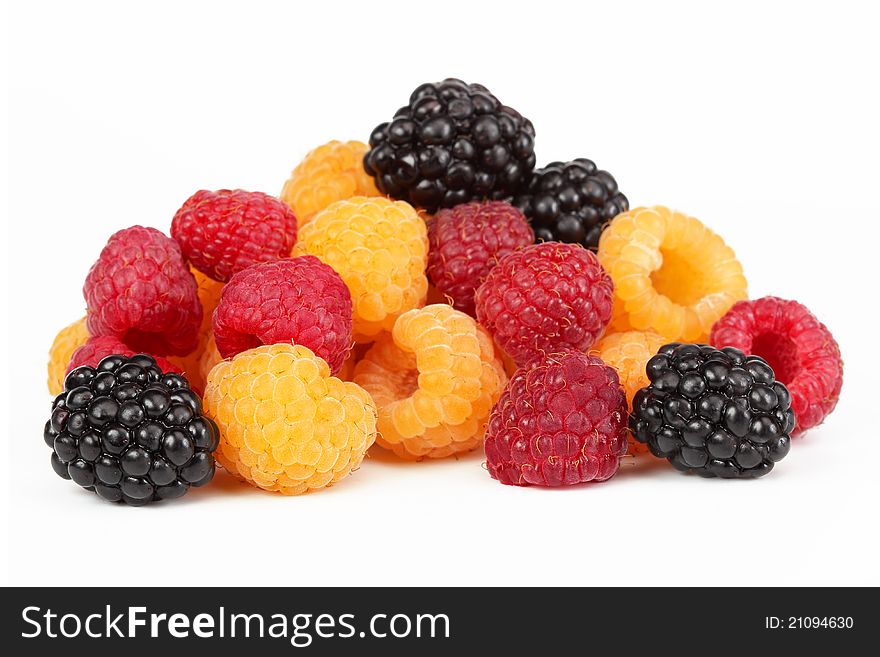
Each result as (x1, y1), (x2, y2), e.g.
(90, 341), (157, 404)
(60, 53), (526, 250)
(364, 78), (535, 213)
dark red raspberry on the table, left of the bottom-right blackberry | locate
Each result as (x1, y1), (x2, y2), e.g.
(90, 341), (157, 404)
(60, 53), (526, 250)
(486, 351), (627, 486)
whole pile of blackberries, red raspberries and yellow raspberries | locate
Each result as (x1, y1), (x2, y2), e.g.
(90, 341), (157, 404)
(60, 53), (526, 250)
(43, 79), (843, 505)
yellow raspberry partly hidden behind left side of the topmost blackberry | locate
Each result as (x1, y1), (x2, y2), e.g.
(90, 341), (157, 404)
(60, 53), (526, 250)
(281, 140), (380, 228)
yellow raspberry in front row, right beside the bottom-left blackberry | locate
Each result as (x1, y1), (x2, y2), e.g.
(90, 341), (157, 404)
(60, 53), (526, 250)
(204, 343), (376, 495)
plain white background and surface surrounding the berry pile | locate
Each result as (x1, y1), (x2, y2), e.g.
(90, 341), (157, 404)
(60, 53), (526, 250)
(0, 0), (880, 584)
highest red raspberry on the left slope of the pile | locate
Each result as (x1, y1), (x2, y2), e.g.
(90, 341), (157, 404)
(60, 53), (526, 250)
(171, 189), (297, 282)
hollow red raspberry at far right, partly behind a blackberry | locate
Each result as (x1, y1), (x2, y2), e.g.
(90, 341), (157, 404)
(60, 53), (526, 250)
(710, 297), (843, 435)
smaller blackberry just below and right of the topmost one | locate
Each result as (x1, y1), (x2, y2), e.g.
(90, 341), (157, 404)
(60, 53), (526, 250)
(513, 158), (629, 249)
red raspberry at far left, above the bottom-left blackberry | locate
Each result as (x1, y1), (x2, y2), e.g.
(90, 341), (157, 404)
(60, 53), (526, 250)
(83, 226), (202, 356)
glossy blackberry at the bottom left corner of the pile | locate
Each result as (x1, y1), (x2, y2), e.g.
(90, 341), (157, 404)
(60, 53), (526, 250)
(43, 354), (219, 506)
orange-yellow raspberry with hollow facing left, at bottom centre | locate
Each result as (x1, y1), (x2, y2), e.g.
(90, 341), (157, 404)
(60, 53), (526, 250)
(354, 304), (507, 459)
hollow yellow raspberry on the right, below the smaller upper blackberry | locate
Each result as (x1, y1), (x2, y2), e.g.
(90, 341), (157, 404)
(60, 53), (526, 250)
(598, 206), (747, 342)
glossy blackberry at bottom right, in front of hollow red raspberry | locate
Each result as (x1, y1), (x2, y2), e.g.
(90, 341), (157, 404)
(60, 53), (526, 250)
(629, 343), (795, 478)
